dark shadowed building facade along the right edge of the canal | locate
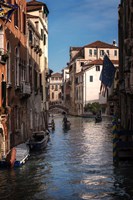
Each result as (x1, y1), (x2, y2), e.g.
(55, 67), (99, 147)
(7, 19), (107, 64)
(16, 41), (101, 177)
(118, 0), (133, 130)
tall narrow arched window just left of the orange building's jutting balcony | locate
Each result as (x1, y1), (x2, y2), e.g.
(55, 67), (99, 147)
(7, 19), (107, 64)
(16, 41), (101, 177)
(15, 47), (20, 87)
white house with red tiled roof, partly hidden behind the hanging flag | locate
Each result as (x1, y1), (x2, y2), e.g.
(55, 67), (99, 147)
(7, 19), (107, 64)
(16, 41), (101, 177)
(83, 59), (119, 114)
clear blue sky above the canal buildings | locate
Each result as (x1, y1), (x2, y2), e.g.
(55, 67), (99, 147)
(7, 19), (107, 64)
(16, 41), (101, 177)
(43, 0), (120, 72)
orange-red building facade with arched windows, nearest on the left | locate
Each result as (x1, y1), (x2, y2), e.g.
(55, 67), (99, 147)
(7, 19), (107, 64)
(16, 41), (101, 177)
(0, 0), (27, 153)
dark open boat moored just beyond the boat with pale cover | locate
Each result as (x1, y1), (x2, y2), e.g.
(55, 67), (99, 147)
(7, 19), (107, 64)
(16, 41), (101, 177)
(28, 131), (49, 150)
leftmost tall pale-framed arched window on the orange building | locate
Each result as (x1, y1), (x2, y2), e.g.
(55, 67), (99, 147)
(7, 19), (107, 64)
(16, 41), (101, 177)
(7, 42), (11, 86)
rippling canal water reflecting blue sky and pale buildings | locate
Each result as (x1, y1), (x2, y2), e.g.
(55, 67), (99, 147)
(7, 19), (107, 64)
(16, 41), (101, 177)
(0, 116), (133, 200)
